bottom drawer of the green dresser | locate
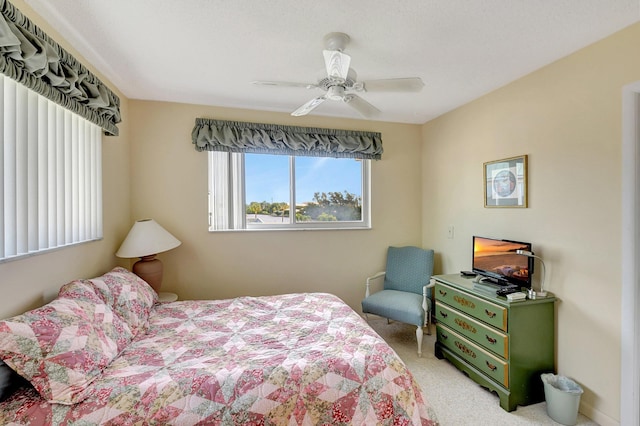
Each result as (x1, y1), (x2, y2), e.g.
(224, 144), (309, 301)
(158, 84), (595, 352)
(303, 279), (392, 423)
(436, 324), (509, 389)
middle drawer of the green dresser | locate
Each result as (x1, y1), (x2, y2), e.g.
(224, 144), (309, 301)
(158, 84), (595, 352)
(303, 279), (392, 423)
(436, 303), (509, 359)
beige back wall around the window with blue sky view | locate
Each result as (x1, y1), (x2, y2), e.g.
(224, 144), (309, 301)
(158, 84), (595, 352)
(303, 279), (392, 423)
(130, 100), (422, 311)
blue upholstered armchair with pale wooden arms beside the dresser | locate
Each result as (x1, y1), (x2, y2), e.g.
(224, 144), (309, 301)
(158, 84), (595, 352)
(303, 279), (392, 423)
(362, 247), (433, 356)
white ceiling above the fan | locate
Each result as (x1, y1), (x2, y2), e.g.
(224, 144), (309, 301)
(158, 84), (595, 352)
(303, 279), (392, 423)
(25, 0), (640, 123)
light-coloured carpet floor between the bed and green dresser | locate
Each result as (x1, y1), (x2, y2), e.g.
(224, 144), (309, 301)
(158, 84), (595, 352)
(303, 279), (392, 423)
(369, 315), (597, 426)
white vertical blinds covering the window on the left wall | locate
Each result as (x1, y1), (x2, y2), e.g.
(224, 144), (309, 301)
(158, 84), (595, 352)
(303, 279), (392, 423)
(0, 75), (103, 261)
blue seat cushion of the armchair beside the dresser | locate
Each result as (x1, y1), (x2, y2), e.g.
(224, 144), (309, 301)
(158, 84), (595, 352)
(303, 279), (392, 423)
(362, 290), (431, 327)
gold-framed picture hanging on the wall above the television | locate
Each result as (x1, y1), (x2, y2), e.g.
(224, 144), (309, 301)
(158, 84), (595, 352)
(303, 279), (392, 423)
(483, 155), (529, 208)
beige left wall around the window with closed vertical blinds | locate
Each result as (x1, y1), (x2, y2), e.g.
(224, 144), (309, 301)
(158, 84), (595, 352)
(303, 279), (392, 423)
(0, 0), (131, 318)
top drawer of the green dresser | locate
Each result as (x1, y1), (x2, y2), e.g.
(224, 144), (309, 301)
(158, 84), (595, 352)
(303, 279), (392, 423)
(436, 282), (507, 331)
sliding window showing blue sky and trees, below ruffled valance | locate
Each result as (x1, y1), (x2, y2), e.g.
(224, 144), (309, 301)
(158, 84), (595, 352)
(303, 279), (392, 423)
(209, 151), (371, 231)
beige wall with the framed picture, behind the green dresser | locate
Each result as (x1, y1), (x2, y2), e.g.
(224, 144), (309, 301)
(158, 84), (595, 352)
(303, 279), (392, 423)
(422, 25), (640, 424)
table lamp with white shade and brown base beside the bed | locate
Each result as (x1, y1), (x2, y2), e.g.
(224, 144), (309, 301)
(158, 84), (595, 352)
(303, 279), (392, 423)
(116, 219), (182, 293)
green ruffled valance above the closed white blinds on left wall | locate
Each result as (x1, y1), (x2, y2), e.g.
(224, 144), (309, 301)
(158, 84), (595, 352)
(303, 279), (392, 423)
(0, 0), (121, 135)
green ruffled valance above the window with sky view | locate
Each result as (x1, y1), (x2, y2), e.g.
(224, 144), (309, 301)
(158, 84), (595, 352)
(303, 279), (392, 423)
(191, 118), (382, 160)
